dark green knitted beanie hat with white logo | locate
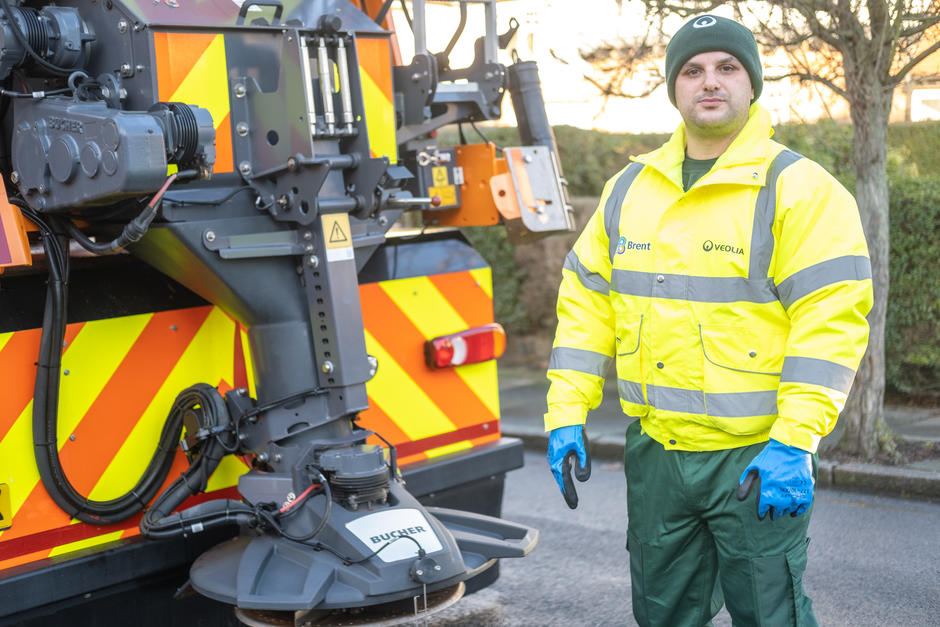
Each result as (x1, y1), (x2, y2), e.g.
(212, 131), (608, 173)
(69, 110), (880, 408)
(666, 15), (764, 105)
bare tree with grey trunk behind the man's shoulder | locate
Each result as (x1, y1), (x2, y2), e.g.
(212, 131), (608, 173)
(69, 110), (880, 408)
(582, 0), (940, 457)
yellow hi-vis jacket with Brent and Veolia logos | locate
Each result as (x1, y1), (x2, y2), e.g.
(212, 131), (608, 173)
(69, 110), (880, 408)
(545, 104), (873, 452)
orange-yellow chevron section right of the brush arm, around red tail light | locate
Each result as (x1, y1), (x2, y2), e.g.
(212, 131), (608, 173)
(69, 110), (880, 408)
(359, 268), (499, 465)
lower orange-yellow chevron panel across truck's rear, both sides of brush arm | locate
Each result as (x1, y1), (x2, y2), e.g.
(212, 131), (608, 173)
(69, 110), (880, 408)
(0, 268), (500, 569)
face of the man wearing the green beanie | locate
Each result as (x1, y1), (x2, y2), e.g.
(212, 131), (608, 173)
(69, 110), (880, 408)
(676, 51), (754, 139)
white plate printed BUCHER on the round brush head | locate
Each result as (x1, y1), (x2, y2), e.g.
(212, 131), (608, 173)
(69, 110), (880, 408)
(346, 509), (443, 562)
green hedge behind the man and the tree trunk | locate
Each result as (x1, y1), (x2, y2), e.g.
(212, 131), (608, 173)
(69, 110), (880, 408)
(450, 122), (940, 397)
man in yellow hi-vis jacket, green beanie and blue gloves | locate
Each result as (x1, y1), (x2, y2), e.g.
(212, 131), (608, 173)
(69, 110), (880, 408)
(545, 15), (872, 626)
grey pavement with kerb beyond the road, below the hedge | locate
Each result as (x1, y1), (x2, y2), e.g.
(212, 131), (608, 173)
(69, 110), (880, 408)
(499, 366), (940, 501)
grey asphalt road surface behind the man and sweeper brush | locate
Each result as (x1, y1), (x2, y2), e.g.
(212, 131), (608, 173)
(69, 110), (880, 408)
(430, 453), (940, 627)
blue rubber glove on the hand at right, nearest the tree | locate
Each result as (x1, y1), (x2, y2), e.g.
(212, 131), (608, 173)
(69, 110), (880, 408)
(738, 440), (814, 520)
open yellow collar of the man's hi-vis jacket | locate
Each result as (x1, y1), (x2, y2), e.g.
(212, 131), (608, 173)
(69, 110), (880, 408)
(631, 102), (778, 189)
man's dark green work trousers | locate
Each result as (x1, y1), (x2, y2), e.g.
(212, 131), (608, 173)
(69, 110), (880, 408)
(624, 420), (817, 627)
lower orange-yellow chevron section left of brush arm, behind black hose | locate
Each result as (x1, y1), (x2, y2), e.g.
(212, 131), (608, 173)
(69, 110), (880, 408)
(0, 306), (249, 569)
